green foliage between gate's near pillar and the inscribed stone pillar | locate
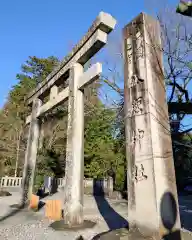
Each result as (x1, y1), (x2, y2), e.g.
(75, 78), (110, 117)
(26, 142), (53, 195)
(85, 105), (125, 189)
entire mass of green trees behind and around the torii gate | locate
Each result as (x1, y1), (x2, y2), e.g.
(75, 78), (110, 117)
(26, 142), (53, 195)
(0, 57), (125, 191)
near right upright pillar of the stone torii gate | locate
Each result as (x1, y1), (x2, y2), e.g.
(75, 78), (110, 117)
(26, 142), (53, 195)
(64, 63), (84, 226)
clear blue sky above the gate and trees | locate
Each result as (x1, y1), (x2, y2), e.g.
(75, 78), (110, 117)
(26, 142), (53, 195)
(0, 0), (180, 107)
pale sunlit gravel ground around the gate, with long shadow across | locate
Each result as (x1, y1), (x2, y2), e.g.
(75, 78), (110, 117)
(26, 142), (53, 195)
(0, 192), (192, 240)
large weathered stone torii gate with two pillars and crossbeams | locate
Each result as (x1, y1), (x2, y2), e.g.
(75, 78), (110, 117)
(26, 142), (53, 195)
(22, 12), (116, 225)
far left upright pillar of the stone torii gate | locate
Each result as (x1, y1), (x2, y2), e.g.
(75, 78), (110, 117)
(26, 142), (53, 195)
(22, 99), (42, 204)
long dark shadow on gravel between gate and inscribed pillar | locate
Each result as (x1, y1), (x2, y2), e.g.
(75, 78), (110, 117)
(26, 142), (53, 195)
(93, 180), (128, 230)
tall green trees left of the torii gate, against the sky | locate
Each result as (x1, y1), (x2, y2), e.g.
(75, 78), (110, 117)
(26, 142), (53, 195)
(0, 57), (58, 179)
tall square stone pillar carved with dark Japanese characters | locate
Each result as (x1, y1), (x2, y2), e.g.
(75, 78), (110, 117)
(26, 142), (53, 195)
(124, 13), (180, 239)
